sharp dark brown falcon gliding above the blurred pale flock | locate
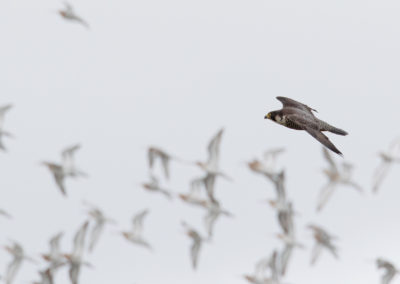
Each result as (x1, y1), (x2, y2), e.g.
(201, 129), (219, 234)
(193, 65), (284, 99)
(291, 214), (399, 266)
(264, 97), (347, 155)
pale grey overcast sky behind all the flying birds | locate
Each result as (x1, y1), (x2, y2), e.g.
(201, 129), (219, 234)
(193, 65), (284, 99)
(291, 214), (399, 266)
(0, 0), (400, 284)
